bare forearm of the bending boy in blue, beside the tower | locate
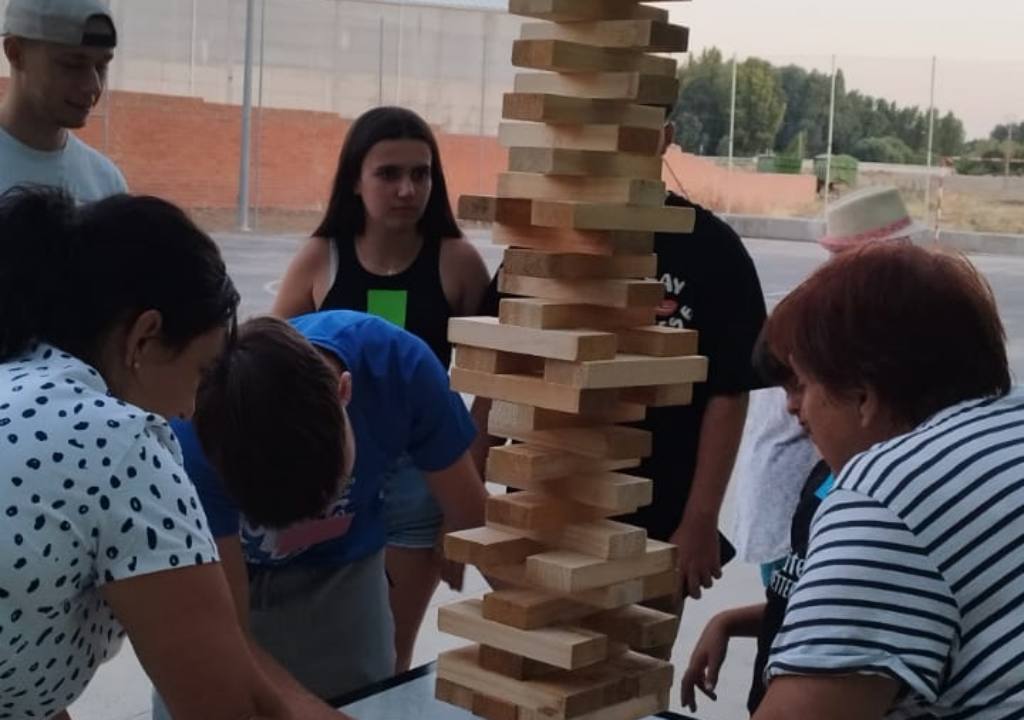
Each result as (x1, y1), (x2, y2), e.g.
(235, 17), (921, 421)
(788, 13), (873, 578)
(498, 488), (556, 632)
(427, 451), (487, 590)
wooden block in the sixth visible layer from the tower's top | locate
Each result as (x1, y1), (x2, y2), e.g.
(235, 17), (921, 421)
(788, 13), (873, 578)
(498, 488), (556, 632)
(498, 123), (662, 156)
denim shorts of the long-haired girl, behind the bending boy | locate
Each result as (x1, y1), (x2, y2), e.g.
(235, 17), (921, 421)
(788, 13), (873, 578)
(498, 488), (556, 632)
(381, 456), (444, 549)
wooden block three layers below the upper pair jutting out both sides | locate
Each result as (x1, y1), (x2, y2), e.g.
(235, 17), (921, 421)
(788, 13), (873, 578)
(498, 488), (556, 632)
(497, 270), (665, 309)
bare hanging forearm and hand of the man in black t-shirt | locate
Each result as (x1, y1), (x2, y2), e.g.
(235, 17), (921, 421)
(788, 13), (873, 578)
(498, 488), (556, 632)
(672, 392), (749, 598)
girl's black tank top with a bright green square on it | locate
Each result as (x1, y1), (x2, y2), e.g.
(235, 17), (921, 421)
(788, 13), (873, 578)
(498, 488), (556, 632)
(321, 239), (454, 370)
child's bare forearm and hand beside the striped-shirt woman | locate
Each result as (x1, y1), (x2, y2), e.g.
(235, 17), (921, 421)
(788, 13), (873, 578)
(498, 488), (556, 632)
(681, 603), (765, 713)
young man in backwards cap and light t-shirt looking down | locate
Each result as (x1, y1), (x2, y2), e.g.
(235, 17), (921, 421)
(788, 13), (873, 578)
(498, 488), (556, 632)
(0, 0), (127, 203)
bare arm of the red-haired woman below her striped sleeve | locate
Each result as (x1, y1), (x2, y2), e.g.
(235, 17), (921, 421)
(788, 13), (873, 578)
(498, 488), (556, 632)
(754, 675), (900, 720)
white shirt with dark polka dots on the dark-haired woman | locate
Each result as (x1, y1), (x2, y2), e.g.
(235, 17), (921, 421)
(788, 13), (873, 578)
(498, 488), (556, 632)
(0, 345), (218, 719)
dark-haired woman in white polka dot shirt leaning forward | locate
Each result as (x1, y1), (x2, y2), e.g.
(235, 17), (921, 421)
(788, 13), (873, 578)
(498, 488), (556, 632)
(0, 188), (348, 720)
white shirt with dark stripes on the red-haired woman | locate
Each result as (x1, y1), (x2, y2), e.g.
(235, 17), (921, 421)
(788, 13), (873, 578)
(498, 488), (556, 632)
(767, 388), (1024, 720)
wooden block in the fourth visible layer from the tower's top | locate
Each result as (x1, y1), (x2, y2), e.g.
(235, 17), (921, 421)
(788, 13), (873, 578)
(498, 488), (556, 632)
(514, 70), (679, 107)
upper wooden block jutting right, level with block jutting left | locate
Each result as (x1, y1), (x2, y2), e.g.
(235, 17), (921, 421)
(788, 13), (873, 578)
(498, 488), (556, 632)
(530, 200), (696, 234)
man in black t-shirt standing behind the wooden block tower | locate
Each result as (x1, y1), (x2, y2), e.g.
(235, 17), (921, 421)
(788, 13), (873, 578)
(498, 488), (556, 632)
(474, 112), (766, 630)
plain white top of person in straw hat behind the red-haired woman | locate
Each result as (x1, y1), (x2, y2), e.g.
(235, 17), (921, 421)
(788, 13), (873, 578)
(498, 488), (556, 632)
(729, 387), (819, 563)
